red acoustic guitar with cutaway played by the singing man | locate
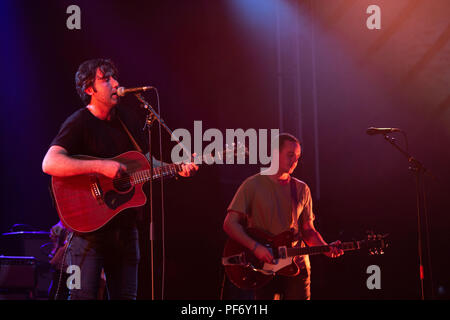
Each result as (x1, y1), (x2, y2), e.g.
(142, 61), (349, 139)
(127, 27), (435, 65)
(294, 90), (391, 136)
(52, 143), (248, 233)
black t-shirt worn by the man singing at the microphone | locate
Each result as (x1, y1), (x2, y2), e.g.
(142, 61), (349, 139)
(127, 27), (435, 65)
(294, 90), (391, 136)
(51, 106), (148, 232)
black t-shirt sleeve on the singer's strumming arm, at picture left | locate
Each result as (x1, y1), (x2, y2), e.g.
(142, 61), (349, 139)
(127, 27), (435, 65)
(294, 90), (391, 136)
(50, 113), (83, 155)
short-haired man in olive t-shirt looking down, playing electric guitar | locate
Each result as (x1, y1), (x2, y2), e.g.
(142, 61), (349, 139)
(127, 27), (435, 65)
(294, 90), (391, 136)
(223, 133), (343, 300)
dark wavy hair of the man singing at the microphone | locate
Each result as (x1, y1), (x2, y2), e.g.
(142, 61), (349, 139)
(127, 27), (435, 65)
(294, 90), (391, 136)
(75, 59), (119, 105)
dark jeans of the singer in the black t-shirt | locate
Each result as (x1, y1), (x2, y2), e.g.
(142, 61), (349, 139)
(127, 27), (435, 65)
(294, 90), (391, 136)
(67, 227), (140, 300)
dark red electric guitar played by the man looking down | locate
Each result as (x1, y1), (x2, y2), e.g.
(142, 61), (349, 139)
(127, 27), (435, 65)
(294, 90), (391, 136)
(222, 228), (387, 289)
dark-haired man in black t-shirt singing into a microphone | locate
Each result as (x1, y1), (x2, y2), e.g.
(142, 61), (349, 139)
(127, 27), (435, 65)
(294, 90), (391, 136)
(42, 59), (198, 300)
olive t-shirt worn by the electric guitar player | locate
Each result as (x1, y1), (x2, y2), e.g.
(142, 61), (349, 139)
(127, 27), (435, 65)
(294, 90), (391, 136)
(227, 173), (314, 268)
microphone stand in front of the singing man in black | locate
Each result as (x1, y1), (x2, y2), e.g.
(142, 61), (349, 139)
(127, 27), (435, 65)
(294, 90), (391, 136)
(135, 92), (190, 300)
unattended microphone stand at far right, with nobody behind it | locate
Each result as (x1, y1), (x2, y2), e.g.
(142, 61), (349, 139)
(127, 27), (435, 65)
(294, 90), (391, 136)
(383, 134), (434, 300)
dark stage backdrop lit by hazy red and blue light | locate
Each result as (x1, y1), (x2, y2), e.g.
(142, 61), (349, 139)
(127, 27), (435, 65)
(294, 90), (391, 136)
(0, 0), (450, 299)
